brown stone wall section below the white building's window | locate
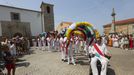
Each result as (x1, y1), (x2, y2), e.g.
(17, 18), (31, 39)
(1, 21), (31, 38)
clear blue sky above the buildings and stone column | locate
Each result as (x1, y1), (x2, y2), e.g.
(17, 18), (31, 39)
(0, 0), (134, 33)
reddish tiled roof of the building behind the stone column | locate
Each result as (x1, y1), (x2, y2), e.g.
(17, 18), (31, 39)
(103, 18), (134, 27)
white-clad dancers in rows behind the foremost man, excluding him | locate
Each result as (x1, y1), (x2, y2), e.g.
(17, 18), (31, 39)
(32, 35), (84, 65)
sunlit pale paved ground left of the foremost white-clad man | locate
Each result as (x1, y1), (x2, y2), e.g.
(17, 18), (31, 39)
(8, 47), (89, 75)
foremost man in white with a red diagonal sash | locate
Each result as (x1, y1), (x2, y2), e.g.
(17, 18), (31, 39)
(90, 37), (111, 75)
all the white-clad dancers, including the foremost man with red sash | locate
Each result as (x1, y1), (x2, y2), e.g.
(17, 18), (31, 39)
(33, 32), (111, 75)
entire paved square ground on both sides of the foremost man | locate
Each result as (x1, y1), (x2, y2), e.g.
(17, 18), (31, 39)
(3, 47), (134, 75)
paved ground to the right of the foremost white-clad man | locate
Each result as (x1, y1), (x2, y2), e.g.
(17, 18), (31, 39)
(108, 47), (134, 75)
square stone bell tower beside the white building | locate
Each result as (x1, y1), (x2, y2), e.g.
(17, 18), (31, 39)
(40, 2), (54, 32)
